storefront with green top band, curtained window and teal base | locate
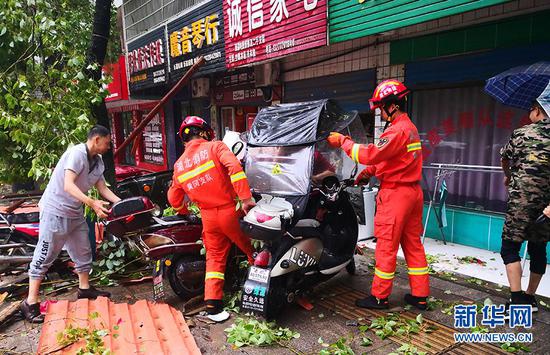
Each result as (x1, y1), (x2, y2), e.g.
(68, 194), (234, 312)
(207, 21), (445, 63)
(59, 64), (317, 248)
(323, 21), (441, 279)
(390, 11), (550, 260)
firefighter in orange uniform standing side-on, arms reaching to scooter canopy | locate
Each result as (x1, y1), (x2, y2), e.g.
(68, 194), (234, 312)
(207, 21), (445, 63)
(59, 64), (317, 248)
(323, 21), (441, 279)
(327, 80), (430, 310)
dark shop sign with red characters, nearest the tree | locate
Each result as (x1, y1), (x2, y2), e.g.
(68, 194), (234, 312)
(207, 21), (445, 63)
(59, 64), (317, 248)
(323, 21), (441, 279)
(127, 27), (168, 91)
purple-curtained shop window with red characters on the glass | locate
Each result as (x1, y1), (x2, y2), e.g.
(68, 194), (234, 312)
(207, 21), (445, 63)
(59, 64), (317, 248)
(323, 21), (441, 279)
(410, 86), (527, 212)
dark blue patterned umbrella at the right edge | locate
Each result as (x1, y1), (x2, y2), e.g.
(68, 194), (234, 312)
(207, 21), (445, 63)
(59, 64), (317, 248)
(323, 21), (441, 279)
(485, 62), (550, 110)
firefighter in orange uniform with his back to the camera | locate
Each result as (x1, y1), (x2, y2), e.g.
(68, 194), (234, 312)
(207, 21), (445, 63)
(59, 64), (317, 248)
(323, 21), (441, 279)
(168, 116), (255, 322)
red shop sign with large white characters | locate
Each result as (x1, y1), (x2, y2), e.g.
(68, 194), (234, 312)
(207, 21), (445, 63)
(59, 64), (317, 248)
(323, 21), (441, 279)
(223, 0), (327, 68)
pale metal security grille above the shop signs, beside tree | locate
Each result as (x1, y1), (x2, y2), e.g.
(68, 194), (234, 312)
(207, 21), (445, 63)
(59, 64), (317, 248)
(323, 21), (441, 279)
(122, 0), (204, 41)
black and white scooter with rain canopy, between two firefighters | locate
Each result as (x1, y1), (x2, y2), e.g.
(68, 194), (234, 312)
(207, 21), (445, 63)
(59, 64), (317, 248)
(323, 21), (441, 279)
(240, 100), (360, 319)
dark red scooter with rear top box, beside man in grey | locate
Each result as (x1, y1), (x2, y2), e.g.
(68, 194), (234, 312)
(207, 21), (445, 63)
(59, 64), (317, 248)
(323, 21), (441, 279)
(103, 196), (206, 300)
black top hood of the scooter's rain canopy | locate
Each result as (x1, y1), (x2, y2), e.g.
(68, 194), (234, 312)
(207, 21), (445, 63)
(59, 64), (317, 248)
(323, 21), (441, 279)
(243, 99), (357, 147)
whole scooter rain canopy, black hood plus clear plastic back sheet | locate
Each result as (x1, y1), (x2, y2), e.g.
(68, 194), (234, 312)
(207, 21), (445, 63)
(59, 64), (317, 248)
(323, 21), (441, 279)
(241, 99), (358, 221)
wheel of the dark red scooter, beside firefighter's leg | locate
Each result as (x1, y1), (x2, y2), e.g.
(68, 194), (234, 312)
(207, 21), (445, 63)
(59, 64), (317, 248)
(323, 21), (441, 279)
(167, 255), (206, 300)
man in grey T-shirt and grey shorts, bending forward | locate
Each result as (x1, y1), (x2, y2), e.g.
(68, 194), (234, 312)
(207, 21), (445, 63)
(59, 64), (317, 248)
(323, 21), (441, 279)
(20, 126), (120, 323)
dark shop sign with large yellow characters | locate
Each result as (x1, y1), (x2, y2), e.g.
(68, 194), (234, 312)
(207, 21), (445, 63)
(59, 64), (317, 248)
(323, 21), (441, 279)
(167, 1), (225, 79)
